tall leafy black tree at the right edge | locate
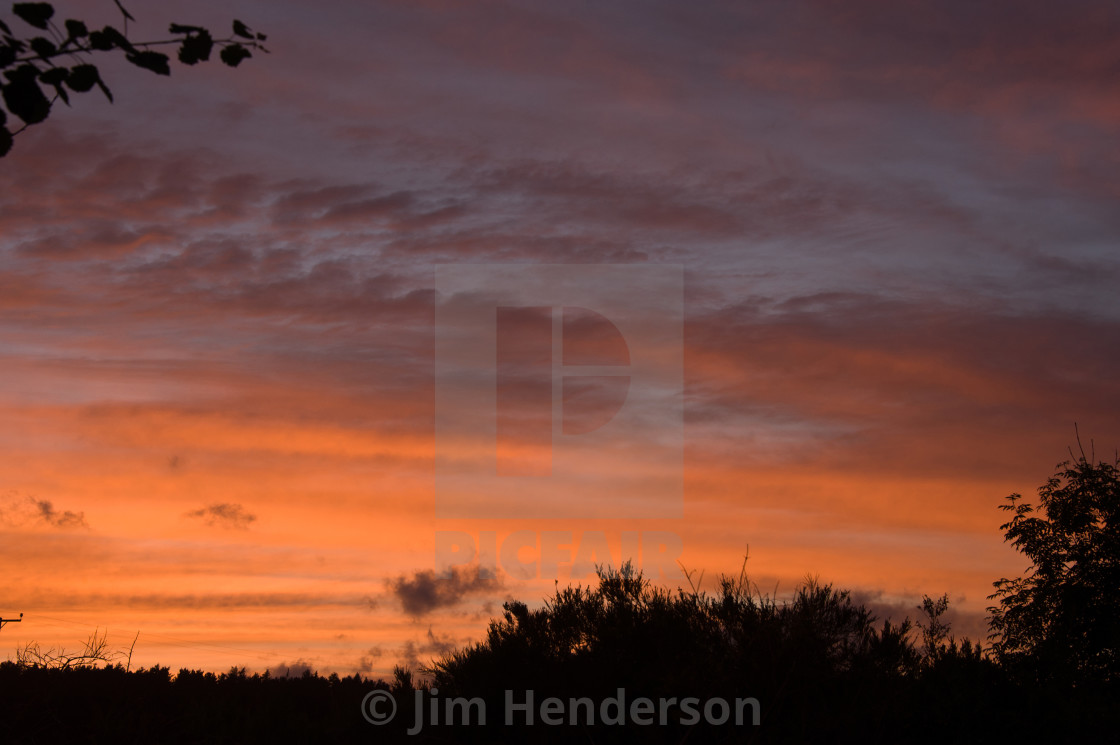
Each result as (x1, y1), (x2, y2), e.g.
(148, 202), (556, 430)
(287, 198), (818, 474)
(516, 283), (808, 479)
(988, 443), (1120, 685)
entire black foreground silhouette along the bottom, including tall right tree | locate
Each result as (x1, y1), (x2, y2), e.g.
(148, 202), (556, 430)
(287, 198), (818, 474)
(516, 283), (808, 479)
(0, 443), (1120, 745)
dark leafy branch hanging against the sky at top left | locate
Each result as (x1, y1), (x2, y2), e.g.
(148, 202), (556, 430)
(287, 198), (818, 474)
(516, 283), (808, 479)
(0, 0), (268, 157)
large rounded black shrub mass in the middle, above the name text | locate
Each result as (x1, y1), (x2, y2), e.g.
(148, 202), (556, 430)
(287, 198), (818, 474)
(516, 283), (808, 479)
(427, 565), (992, 743)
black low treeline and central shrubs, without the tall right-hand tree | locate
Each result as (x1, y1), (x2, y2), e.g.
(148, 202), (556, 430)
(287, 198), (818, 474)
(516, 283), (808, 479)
(0, 566), (1120, 744)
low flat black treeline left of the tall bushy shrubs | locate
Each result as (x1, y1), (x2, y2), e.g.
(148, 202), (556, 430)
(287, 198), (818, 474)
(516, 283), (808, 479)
(0, 662), (403, 745)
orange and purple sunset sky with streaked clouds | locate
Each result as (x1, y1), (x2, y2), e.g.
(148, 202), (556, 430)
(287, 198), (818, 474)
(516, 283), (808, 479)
(0, 0), (1120, 676)
